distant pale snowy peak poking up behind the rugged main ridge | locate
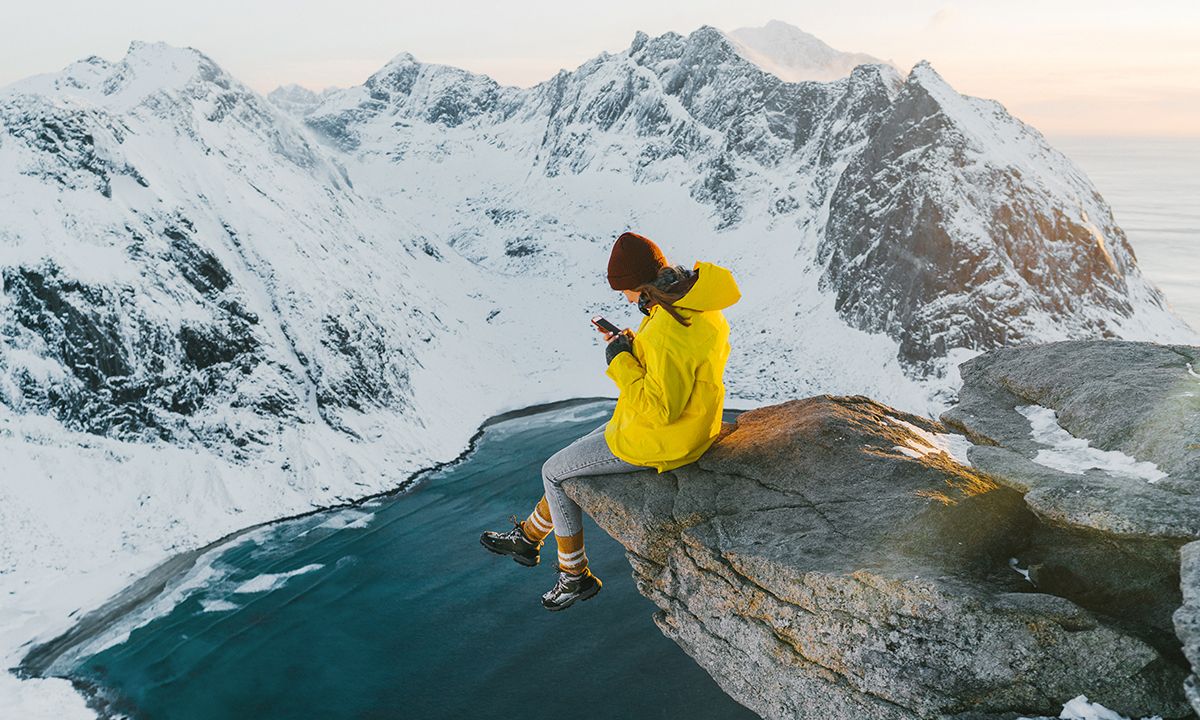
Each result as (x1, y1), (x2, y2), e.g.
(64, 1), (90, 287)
(728, 20), (892, 83)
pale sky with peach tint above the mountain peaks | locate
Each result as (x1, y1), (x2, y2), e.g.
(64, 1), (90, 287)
(7, 0), (1200, 136)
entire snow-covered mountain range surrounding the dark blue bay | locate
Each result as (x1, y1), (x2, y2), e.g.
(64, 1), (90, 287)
(0, 22), (1196, 715)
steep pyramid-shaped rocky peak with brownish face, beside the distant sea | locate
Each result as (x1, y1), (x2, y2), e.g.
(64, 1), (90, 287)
(820, 65), (1135, 376)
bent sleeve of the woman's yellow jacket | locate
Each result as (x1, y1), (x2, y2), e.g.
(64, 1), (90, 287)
(605, 340), (696, 425)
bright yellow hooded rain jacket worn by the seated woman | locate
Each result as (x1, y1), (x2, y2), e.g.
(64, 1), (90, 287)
(604, 262), (742, 473)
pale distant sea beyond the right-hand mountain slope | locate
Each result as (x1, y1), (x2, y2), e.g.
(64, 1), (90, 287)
(1050, 137), (1200, 330)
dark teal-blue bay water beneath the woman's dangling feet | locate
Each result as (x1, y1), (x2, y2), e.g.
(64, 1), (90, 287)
(60, 403), (755, 720)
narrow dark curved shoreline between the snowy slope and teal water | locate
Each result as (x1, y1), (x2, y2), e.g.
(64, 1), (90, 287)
(14, 396), (616, 686)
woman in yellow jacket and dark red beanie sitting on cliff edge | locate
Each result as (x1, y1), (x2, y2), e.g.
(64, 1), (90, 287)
(479, 233), (742, 610)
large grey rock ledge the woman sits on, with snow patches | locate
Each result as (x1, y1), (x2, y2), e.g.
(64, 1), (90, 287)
(566, 342), (1200, 720)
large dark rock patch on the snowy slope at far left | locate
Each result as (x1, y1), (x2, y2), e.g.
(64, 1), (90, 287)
(0, 248), (278, 449)
